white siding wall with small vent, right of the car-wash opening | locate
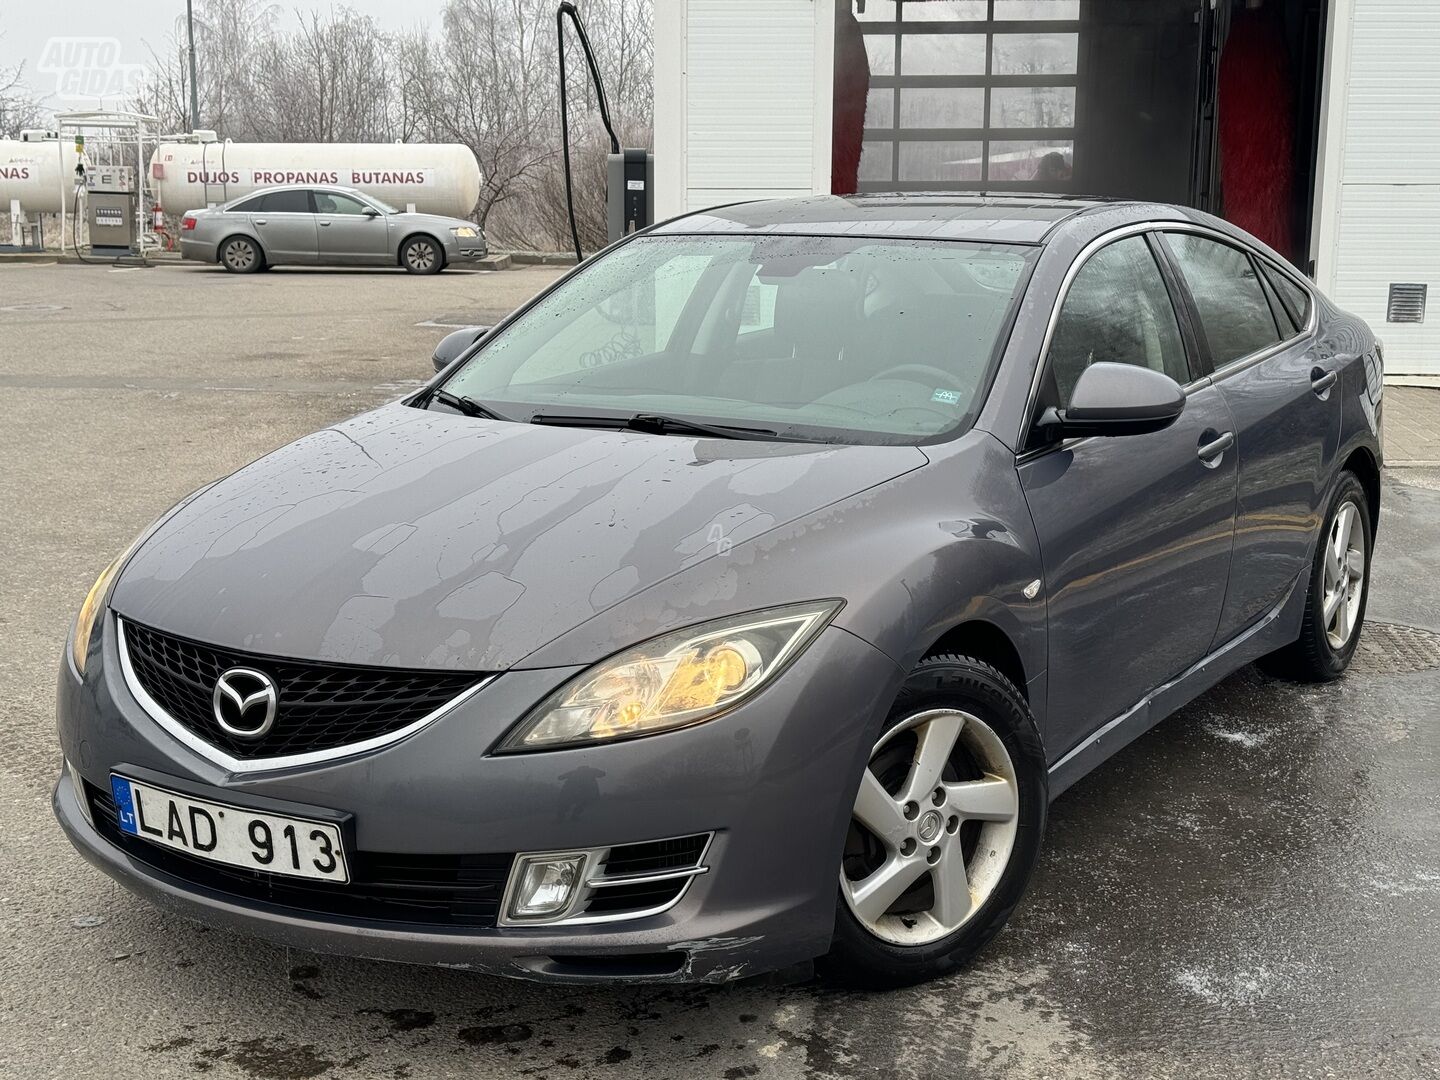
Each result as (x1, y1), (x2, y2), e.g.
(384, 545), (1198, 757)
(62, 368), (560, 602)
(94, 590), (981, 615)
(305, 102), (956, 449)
(1331, 0), (1440, 374)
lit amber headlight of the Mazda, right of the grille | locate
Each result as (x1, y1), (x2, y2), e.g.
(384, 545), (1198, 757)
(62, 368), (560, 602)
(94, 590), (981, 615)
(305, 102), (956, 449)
(495, 600), (841, 753)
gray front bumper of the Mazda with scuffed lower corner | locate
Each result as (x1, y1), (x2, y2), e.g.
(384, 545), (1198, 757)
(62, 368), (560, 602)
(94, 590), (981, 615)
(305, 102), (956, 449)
(55, 618), (900, 982)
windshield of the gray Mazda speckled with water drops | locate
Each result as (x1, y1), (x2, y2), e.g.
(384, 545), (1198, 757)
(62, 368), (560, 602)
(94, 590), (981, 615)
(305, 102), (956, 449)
(445, 236), (1035, 442)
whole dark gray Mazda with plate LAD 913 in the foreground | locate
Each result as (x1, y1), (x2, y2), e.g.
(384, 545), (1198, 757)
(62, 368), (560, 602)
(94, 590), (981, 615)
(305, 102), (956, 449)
(55, 196), (1381, 986)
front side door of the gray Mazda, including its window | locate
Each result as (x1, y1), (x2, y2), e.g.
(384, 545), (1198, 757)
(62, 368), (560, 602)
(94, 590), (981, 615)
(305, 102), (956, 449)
(1020, 232), (1237, 757)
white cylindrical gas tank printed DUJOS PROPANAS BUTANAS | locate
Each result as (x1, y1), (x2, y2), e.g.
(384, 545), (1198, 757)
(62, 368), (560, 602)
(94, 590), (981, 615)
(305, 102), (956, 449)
(150, 143), (481, 217)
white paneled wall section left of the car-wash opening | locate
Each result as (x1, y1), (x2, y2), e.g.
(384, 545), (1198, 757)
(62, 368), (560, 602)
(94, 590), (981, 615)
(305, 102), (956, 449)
(655, 0), (834, 219)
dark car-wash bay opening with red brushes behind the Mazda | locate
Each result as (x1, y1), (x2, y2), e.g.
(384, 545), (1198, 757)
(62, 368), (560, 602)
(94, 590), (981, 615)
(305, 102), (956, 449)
(832, 0), (1325, 269)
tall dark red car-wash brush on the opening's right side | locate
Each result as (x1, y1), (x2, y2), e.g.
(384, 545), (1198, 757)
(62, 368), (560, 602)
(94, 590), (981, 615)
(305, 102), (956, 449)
(1218, 7), (1295, 255)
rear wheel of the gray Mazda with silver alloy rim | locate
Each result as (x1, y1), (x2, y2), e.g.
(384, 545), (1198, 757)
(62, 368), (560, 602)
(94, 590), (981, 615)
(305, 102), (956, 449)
(1260, 472), (1375, 683)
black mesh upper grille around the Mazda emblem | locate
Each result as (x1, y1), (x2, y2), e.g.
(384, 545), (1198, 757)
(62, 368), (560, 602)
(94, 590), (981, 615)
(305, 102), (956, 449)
(122, 619), (485, 760)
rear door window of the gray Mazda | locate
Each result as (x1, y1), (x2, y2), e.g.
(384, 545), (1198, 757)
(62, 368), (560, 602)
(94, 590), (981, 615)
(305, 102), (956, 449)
(1165, 233), (1280, 367)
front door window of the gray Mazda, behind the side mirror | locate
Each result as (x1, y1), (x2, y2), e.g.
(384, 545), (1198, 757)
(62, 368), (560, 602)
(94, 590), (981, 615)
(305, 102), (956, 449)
(1050, 236), (1189, 406)
